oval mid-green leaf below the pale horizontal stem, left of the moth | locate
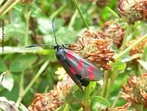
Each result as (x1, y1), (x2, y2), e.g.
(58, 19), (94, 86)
(10, 54), (37, 72)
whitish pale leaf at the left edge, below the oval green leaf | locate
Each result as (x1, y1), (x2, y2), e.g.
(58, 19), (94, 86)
(0, 71), (14, 91)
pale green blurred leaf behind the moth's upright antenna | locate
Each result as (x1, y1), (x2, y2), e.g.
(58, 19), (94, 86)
(38, 18), (77, 45)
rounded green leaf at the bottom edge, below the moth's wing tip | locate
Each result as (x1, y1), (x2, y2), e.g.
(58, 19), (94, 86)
(91, 96), (110, 111)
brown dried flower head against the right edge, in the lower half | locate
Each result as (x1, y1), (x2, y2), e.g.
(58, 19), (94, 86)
(121, 73), (147, 108)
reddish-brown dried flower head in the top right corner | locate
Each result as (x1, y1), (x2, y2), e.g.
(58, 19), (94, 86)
(118, 0), (147, 24)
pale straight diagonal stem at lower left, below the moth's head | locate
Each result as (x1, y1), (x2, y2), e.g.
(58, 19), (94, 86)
(16, 60), (49, 105)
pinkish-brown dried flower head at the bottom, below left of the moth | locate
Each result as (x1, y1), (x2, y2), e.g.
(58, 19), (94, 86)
(28, 76), (74, 111)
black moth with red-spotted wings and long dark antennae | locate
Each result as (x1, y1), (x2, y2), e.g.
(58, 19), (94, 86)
(27, 19), (104, 90)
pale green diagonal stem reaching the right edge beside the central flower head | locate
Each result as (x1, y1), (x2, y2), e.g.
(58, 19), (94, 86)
(115, 34), (147, 60)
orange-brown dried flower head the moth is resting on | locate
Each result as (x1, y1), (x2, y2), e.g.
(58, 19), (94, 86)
(69, 30), (114, 70)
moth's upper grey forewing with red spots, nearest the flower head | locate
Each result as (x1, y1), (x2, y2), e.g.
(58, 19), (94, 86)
(64, 49), (104, 81)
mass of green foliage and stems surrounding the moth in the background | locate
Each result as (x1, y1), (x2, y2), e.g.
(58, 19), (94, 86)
(0, 0), (147, 111)
